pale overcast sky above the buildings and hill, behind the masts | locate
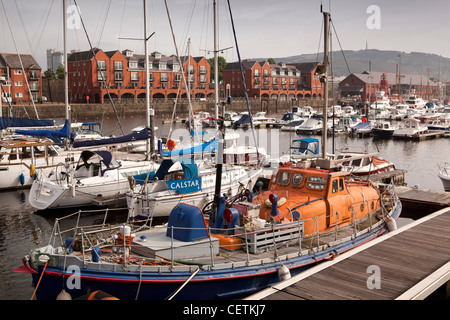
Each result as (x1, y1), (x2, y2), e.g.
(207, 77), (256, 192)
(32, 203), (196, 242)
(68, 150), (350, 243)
(0, 0), (450, 70)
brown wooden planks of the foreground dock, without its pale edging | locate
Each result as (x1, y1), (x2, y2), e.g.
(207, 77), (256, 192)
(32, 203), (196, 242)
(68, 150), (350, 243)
(255, 209), (450, 300)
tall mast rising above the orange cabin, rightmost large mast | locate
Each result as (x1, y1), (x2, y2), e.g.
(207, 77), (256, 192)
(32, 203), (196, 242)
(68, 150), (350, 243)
(321, 8), (334, 159)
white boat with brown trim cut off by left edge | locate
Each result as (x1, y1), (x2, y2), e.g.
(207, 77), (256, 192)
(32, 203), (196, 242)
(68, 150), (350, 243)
(0, 137), (80, 190)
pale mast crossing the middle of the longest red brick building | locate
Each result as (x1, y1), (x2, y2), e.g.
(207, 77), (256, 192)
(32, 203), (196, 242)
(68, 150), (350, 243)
(144, 0), (155, 159)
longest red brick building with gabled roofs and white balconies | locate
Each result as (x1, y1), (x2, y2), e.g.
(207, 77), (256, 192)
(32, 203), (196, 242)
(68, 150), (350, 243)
(68, 48), (213, 103)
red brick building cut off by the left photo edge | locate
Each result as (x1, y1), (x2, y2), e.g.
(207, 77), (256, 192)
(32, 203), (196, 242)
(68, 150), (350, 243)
(0, 53), (42, 104)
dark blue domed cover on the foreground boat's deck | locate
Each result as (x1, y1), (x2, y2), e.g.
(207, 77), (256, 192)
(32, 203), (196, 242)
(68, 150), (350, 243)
(166, 203), (208, 242)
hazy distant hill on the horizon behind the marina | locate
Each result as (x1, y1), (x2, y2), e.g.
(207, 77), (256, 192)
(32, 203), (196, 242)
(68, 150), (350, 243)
(268, 49), (450, 82)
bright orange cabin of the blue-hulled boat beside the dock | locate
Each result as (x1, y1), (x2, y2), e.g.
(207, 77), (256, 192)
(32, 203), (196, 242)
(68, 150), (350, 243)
(259, 161), (380, 236)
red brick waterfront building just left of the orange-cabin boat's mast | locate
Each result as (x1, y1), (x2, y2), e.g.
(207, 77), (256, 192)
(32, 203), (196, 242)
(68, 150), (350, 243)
(223, 60), (323, 101)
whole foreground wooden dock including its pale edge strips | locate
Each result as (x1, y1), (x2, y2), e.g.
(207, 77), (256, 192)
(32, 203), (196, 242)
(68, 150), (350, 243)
(245, 208), (450, 300)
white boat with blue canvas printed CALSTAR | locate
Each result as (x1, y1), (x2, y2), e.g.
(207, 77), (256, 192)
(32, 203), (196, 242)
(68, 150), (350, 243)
(127, 159), (262, 219)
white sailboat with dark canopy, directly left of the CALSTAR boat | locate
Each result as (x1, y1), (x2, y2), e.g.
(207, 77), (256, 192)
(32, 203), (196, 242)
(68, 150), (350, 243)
(29, 150), (157, 210)
